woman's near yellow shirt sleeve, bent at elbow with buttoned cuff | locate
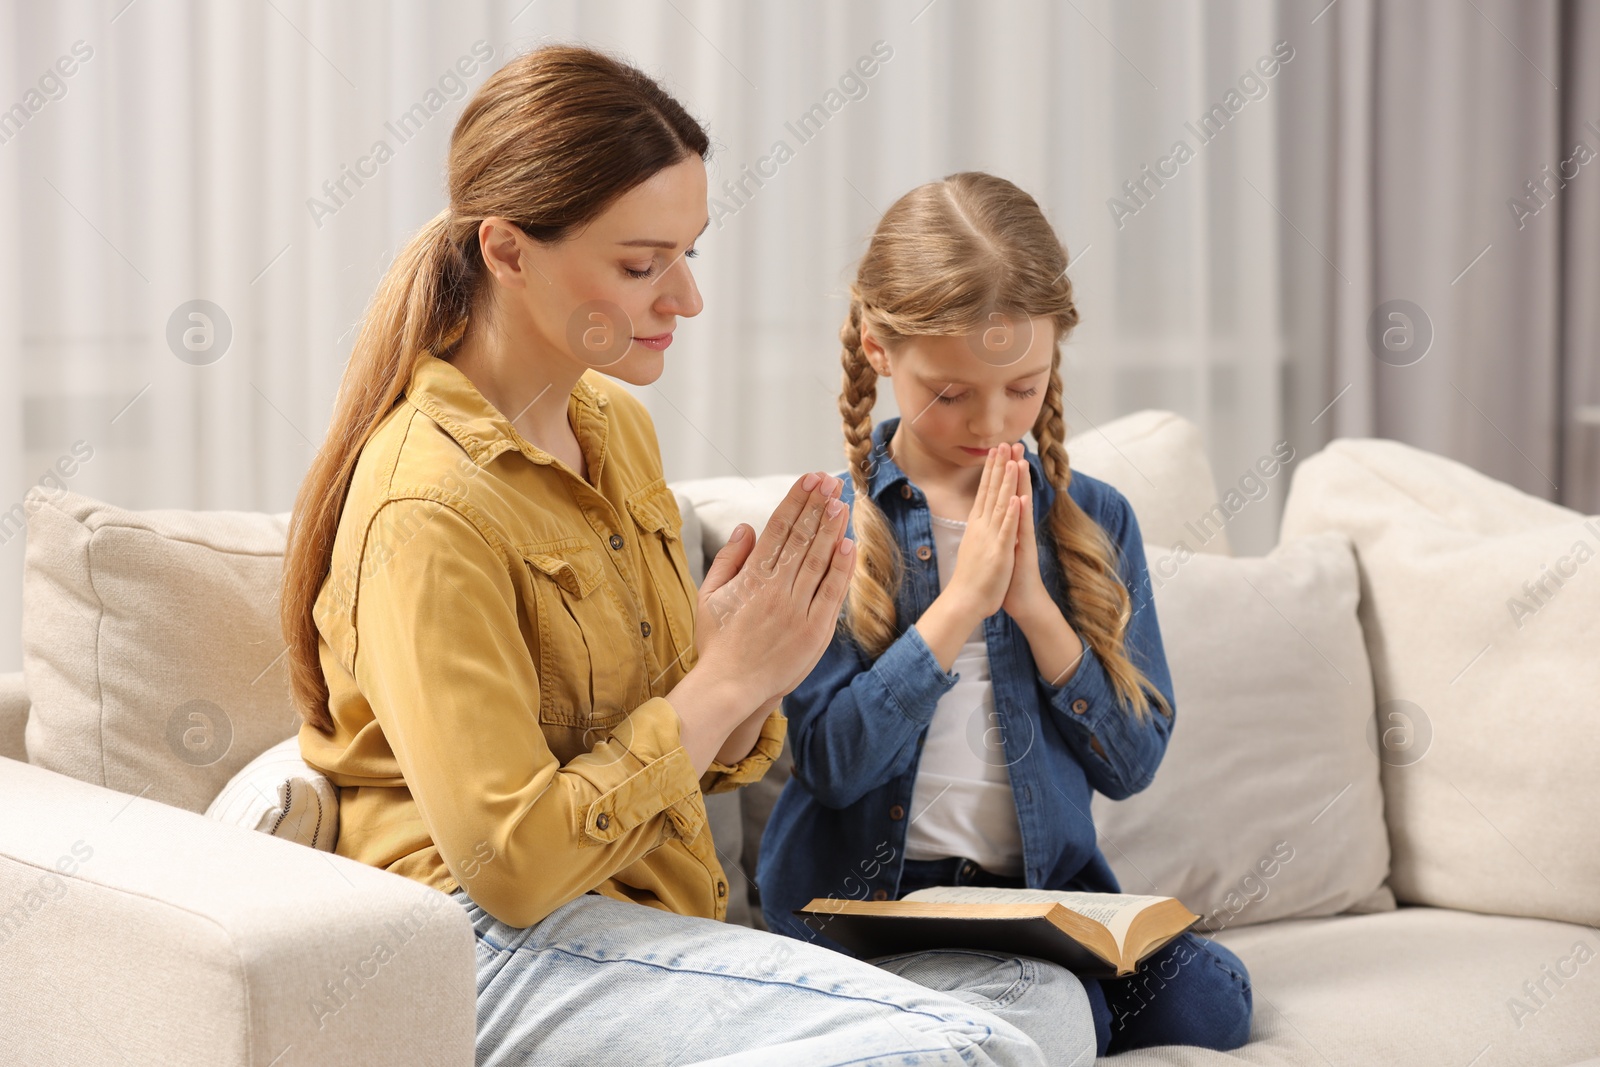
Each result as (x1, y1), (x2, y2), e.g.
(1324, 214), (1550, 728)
(354, 499), (707, 926)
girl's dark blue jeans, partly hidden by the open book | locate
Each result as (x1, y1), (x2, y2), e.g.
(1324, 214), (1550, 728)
(899, 856), (1253, 1056)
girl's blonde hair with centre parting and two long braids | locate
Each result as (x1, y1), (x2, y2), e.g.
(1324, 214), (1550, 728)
(838, 171), (1171, 721)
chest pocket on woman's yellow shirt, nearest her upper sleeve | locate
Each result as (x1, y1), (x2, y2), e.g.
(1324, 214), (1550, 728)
(520, 537), (640, 731)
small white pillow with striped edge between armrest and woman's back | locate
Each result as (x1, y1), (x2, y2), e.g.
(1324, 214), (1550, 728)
(205, 736), (339, 853)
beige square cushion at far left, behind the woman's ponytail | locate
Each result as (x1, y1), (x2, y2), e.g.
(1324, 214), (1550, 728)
(22, 488), (299, 813)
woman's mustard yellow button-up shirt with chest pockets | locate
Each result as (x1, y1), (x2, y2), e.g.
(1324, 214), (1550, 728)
(299, 354), (786, 926)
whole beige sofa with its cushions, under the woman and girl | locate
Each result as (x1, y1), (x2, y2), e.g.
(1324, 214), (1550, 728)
(0, 411), (1600, 1067)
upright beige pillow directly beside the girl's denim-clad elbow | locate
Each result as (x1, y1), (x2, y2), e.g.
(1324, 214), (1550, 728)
(1093, 533), (1394, 933)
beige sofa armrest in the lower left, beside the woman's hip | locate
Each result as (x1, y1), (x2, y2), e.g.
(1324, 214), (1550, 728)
(0, 758), (477, 1067)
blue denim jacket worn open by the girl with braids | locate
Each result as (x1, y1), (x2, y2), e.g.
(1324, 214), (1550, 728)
(757, 418), (1176, 949)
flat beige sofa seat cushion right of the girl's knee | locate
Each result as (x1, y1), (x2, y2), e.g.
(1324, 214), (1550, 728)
(1104, 908), (1600, 1067)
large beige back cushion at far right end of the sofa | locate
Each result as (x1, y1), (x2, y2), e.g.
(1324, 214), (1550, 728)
(1282, 440), (1600, 923)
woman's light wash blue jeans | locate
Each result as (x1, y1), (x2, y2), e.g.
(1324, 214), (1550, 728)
(451, 889), (1094, 1067)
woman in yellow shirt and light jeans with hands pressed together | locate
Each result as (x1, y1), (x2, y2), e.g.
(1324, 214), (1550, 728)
(283, 48), (1094, 1064)
